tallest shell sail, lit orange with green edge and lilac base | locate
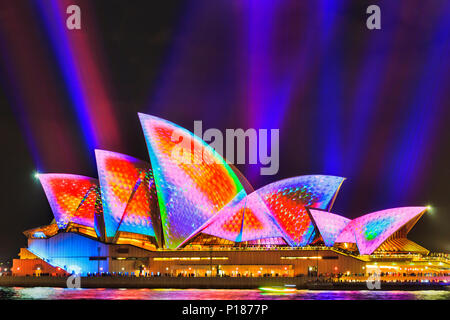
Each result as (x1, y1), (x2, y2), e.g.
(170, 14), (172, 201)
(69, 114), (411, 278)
(139, 113), (243, 249)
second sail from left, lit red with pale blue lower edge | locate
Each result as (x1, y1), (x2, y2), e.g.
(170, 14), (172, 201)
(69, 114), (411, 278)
(95, 150), (156, 237)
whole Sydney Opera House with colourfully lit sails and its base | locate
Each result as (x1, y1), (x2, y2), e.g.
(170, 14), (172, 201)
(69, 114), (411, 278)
(12, 114), (450, 277)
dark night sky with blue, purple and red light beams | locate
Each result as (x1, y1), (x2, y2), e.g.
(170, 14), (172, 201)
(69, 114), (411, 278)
(0, 0), (450, 261)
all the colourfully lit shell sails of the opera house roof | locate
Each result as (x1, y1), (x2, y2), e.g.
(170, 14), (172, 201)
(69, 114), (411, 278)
(34, 114), (426, 254)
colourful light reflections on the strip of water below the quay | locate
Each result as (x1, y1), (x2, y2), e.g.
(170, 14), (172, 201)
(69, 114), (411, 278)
(0, 287), (450, 300)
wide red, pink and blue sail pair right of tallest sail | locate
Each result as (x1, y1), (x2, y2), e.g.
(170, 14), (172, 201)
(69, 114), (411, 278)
(202, 176), (344, 246)
